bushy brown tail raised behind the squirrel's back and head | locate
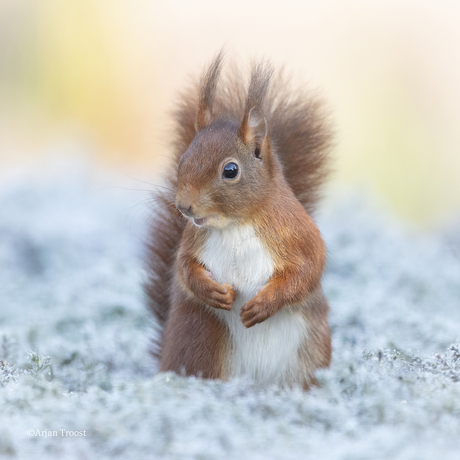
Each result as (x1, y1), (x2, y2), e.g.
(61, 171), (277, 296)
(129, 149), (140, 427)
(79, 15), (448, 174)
(145, 53), (332, 357)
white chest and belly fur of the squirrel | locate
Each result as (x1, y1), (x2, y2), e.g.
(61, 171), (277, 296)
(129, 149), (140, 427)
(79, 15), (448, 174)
(201, 225), (307, 385)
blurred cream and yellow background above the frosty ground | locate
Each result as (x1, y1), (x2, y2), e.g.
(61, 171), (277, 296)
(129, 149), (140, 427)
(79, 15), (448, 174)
(0, 0), (460, 228)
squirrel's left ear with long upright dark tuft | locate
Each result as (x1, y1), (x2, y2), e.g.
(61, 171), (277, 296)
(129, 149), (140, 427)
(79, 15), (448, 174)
(195, 51), (224, 132)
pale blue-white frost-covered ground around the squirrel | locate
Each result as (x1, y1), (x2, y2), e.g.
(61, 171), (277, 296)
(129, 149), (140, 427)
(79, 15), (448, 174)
(0, 160), (460, 460)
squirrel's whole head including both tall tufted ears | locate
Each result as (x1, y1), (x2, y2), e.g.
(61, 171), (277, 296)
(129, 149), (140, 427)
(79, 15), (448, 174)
(176, 53), (280, 228)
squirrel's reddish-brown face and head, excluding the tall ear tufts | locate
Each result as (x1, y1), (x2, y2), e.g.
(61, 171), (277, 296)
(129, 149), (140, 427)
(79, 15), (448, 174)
(176, 119), (277, 228)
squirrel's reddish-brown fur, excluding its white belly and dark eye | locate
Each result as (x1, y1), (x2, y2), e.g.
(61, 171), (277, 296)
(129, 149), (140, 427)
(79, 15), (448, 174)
(146, 54), (331, 387)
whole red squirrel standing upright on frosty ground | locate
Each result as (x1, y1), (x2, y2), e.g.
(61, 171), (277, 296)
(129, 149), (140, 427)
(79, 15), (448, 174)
(145, 53), (331, 389)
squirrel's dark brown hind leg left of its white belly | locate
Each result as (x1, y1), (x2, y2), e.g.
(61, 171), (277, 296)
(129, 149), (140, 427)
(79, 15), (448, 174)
(160, 293), (228, 379)
